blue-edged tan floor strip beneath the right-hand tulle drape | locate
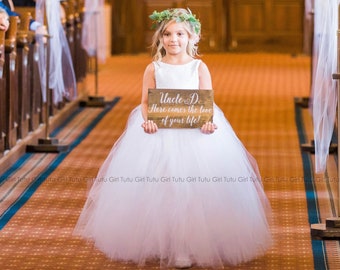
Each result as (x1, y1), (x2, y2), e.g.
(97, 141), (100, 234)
(295, 96), (340, 270)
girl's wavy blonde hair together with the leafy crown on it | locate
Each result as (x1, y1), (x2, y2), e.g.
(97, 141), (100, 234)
(150, 8), (201, 61)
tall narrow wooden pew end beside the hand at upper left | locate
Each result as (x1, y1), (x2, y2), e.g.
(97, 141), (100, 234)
(4, 16), (19, 149)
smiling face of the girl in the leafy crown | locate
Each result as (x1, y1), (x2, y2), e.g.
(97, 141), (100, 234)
(162, 22), (189, 55)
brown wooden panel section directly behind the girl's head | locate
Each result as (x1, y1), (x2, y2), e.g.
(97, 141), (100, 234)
(111, 0), (226, 54)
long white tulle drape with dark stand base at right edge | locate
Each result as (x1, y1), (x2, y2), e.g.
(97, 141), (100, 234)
(311, 0), (340, 238)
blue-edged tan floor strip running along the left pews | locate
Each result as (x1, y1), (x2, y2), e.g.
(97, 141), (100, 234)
(0, 98), (119, 229)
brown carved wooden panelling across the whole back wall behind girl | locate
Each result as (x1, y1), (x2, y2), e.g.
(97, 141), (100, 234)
(111, 0), (304, 54)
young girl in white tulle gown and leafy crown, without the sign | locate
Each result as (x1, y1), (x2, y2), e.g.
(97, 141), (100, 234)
(75, 9), (271, 268)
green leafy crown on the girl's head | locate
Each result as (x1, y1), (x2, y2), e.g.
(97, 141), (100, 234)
(149, 9), (201, 35)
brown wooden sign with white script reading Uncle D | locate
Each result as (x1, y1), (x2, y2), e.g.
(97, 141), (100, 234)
(148, 89), (214, 128)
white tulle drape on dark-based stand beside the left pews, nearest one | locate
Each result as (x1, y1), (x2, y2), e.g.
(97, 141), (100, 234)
(26, 0), (77, 152)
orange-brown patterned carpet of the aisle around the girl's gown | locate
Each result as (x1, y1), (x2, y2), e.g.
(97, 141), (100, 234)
(0, 53), (334, 270)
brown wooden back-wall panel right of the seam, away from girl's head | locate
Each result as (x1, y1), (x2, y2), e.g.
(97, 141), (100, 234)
(228, 0), (304, 52)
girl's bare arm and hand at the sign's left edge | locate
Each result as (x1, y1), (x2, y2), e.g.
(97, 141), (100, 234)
(141, 63), (158, 134)
